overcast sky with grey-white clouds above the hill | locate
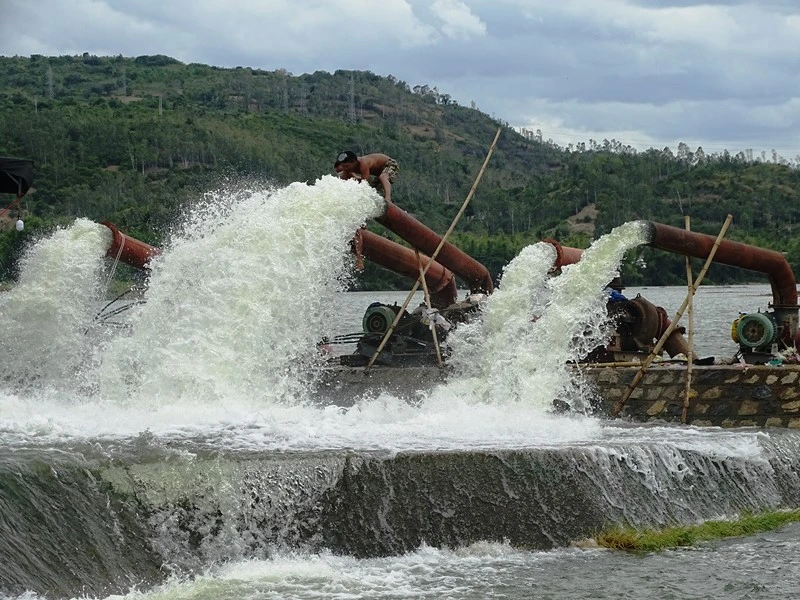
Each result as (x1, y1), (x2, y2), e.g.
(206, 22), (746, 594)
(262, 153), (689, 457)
(0, 0), (800, 159)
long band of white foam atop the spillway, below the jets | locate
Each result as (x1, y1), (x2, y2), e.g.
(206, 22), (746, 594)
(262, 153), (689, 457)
(0, 386), (601, 453)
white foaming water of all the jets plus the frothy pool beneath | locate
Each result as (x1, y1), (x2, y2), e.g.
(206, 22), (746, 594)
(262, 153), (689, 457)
(0, 185), (764, 462)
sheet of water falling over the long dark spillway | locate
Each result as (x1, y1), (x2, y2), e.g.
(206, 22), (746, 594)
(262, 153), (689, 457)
(0, 427), (800, 597)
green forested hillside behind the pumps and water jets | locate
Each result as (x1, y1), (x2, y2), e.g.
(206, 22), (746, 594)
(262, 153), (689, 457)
(0, 54), (800, 287)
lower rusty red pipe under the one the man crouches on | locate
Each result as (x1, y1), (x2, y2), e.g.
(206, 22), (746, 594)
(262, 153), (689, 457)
(356, 229), (458, 308)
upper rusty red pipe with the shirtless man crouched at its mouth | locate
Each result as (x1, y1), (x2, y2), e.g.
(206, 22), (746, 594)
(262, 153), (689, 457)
(375, 202), (494, 294)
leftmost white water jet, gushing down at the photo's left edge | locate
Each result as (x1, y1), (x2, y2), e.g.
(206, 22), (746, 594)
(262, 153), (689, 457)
(0, 219), (111, 389)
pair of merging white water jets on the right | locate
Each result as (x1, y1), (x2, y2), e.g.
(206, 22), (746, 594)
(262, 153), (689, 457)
(440, 223), (646, 410)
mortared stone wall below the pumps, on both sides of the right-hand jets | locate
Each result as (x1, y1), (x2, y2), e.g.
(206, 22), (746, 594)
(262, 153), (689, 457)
(316, 364), (800, 429)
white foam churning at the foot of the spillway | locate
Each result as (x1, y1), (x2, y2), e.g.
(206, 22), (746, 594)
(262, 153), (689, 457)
(86, 542), (552, 600)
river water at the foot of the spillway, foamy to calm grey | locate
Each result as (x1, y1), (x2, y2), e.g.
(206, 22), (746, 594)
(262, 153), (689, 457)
(104, 525), (800, 600)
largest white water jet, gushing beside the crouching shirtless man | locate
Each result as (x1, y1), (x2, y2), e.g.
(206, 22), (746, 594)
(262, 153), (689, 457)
(96, 176), (382, 405)
